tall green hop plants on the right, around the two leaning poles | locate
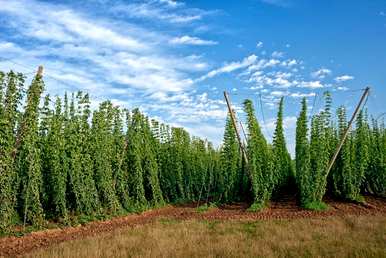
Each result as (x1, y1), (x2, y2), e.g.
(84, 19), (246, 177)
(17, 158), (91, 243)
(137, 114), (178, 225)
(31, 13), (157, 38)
(221, 92), (386, 210)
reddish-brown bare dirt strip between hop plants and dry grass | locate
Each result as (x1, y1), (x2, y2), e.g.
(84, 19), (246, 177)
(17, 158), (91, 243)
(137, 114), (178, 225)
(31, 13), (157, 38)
(0, 197), (386, 257)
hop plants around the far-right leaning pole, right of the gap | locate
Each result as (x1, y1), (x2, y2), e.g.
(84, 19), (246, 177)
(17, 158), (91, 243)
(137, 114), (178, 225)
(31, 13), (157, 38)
(295, 92), (386, 209)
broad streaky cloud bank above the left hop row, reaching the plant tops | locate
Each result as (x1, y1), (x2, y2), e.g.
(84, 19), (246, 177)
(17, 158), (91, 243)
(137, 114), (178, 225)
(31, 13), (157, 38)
(0, 0), (226, 143)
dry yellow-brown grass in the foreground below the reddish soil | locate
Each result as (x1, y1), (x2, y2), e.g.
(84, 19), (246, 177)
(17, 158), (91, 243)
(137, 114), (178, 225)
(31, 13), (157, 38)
(29, 215), (386, 257)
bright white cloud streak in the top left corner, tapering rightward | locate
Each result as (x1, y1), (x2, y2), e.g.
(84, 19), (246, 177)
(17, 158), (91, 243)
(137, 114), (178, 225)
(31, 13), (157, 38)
(0, 1), (148, 49)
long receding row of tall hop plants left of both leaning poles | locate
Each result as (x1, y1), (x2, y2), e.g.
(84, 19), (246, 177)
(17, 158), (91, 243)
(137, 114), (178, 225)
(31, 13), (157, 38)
(0, 71), (219, 231)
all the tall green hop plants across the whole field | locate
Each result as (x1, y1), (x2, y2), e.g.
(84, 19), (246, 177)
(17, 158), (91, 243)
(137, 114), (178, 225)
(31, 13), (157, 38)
(0, 71), (386, 230)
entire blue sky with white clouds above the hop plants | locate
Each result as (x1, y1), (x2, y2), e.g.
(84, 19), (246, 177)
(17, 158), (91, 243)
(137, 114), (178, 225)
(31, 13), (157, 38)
(0, 0), (386, 152)
